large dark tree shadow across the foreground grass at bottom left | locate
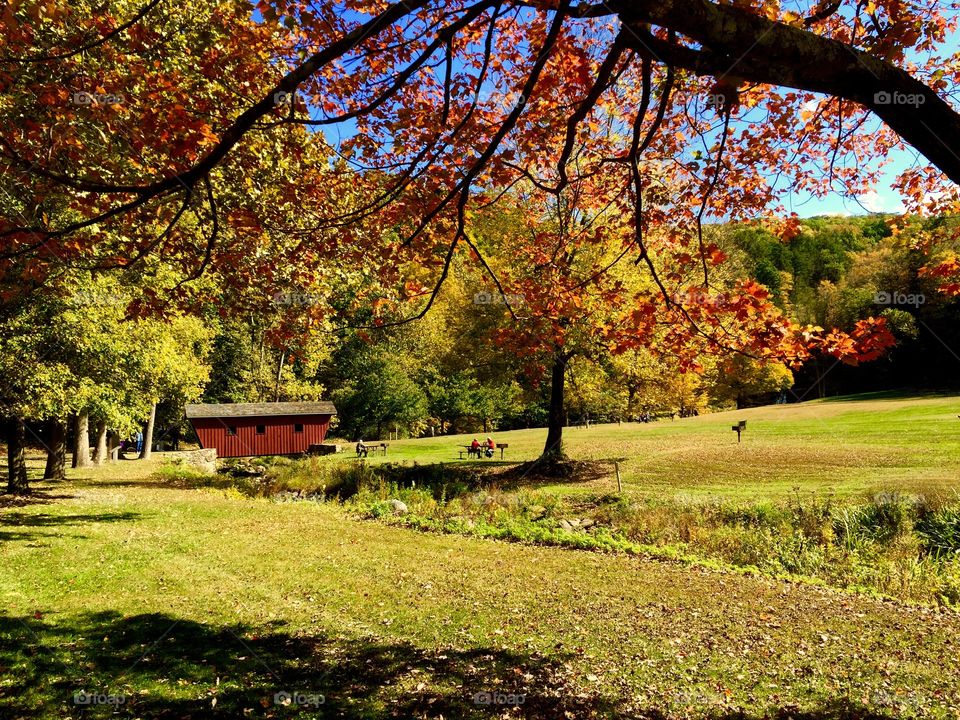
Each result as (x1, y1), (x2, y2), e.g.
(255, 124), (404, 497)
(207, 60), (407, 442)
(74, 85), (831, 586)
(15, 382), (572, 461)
(0, 612), (904, 720)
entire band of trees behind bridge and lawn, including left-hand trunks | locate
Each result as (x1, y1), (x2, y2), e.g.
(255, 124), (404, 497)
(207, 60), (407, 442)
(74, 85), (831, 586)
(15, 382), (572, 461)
(0, 215), (960, 492)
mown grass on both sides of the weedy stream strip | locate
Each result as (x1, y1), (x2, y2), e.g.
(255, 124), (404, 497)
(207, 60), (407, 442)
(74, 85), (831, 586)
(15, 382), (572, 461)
(0, 398), (960, 720)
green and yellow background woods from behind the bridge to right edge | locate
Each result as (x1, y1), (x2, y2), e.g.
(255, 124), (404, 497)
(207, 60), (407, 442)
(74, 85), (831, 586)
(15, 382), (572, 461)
(195, 215), (960, 438)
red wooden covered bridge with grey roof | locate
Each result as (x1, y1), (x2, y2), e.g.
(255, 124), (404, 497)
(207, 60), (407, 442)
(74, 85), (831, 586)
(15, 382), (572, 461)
(186, 402), (337, 457)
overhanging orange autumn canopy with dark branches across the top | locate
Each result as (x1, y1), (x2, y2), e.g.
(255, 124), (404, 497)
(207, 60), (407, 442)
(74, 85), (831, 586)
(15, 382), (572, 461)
(0, 0), (960, 303)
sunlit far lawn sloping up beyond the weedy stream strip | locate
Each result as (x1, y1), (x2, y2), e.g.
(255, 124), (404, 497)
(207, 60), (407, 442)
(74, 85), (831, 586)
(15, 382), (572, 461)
(326, 395), (960, 499)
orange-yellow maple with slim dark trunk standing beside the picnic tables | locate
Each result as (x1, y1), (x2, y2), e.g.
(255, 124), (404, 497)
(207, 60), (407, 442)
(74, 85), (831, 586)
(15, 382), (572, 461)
(468, 181), (824, 458)
